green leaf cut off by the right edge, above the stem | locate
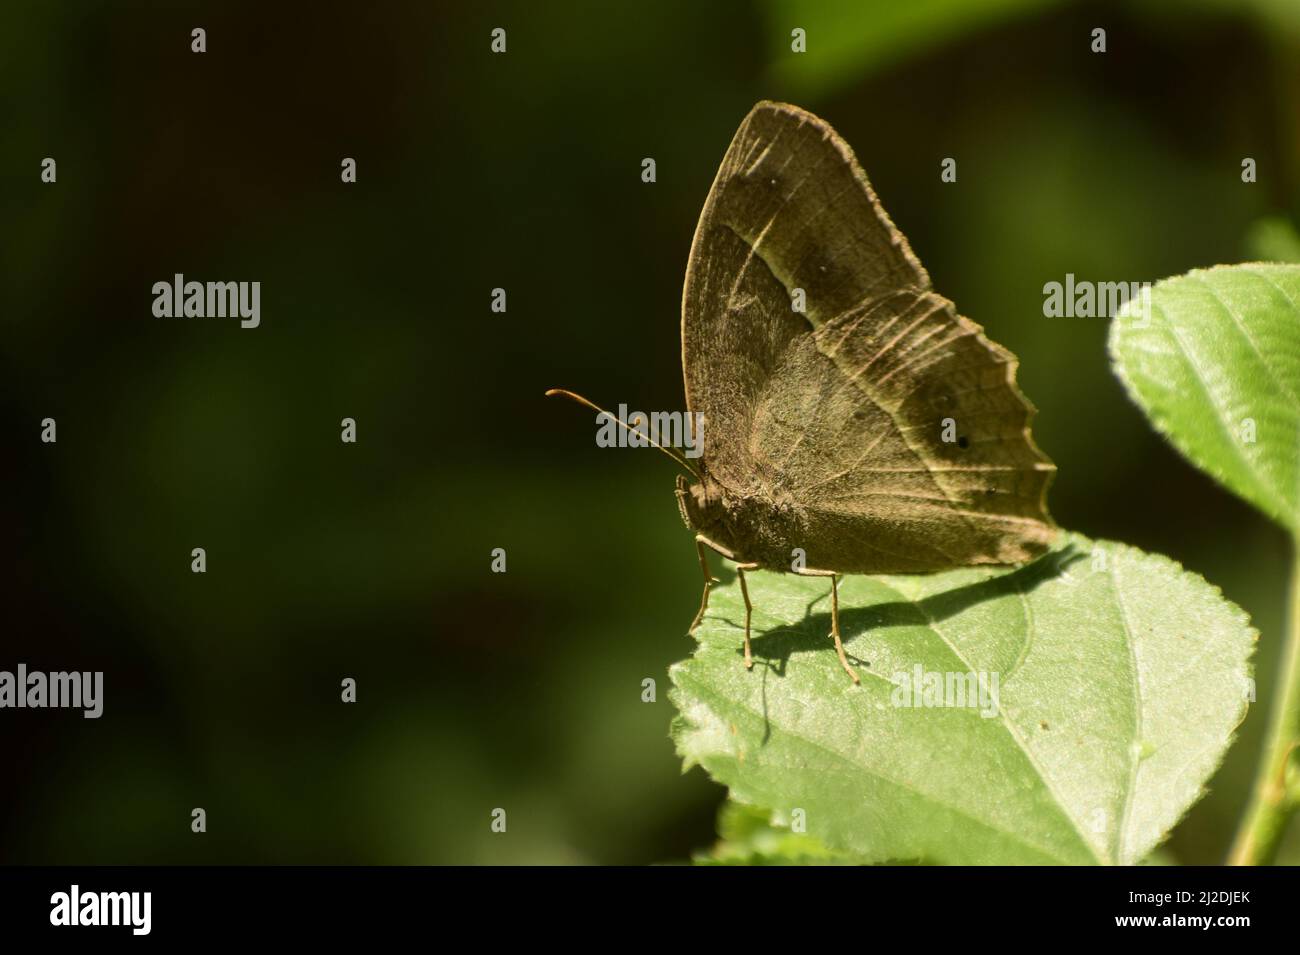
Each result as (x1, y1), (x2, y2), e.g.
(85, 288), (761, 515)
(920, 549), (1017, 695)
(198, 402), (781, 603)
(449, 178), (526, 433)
(1110, 264), (1300, 530)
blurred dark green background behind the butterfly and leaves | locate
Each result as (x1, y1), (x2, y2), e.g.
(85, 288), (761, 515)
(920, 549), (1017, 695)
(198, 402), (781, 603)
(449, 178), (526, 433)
(0, 0), (1300, 863)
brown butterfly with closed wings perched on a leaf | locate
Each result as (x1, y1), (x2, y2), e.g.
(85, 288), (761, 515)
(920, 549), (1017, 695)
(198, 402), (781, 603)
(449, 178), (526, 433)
(547, 103), (1057, 682)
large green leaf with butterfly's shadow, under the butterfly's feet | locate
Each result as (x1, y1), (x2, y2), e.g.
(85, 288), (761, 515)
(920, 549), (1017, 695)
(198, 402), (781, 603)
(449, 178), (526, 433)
(671, 535), (1255, 864)
